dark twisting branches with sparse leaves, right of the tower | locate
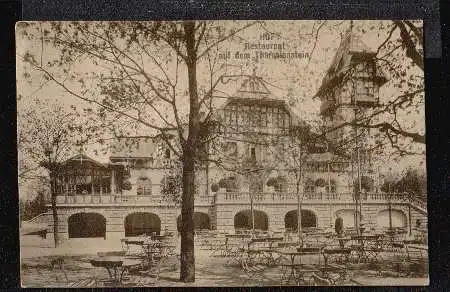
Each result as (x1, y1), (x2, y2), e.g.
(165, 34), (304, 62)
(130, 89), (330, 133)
(316, 21), (425, 156)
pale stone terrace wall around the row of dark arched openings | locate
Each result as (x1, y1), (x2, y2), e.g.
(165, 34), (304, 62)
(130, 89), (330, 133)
(46, 202), (427, 240)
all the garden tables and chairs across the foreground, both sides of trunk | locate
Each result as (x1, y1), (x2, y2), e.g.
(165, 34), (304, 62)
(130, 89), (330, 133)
(21, 228), (428, 288)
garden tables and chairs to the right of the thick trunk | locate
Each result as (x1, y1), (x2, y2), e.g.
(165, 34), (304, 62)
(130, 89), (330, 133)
(197, 229), (428, 285)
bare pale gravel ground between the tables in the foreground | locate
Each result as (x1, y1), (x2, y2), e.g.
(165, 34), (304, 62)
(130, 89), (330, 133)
(21, 237), (428, 288)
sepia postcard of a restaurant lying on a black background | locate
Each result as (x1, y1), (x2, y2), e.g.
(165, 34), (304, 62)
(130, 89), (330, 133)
(16, 20), (429, 288)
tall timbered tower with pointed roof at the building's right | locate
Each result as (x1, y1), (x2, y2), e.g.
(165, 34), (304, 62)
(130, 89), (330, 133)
(316, 29), (388, 178)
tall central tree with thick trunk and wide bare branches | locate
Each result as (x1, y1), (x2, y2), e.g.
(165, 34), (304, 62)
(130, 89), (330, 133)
(18, 21), (257, 282)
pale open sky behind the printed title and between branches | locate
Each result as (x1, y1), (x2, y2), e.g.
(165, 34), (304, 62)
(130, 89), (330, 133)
(17, 21), (425, 182)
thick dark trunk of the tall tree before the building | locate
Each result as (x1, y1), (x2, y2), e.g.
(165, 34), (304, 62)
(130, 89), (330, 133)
(180, 21), (200, 282)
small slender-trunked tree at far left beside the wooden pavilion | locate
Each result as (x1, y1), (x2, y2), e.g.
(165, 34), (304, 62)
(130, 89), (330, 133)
(17, 100), (82, 247)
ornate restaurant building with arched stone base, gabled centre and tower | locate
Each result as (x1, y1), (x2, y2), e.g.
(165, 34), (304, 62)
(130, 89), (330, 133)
(27, 35), (427, 239)
